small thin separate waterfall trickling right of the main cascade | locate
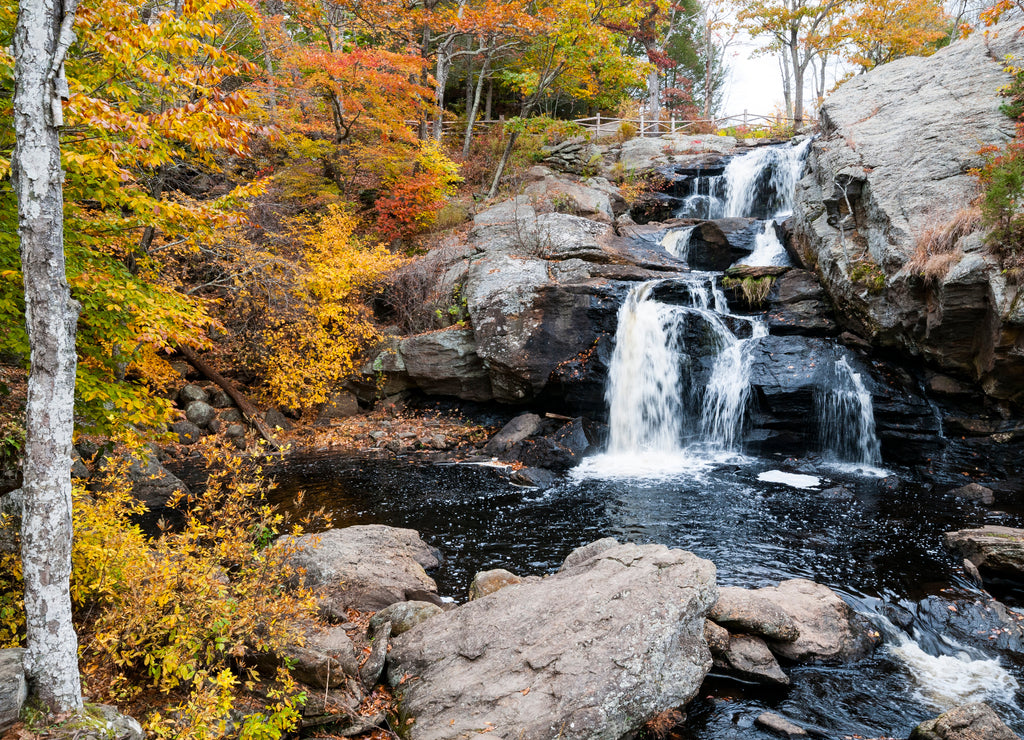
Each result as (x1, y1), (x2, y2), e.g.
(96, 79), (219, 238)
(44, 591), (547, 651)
(816, 357), (882, 467)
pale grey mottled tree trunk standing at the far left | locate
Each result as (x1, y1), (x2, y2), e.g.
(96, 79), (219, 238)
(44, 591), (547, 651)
(12, 0), (82, 712)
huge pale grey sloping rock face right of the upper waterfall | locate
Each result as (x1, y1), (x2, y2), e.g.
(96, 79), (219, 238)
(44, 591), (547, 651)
(793, 23), (1024, 402)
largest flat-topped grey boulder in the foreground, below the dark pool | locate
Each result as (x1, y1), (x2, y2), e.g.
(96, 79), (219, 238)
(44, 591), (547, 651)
(388, 545), (717, 740)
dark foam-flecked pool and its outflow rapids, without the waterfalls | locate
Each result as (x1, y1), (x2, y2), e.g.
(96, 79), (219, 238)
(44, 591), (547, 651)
(276, 458), (1024, 740)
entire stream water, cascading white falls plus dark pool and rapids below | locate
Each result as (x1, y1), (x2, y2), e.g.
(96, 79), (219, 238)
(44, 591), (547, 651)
(274, 144), (1024, 740)
